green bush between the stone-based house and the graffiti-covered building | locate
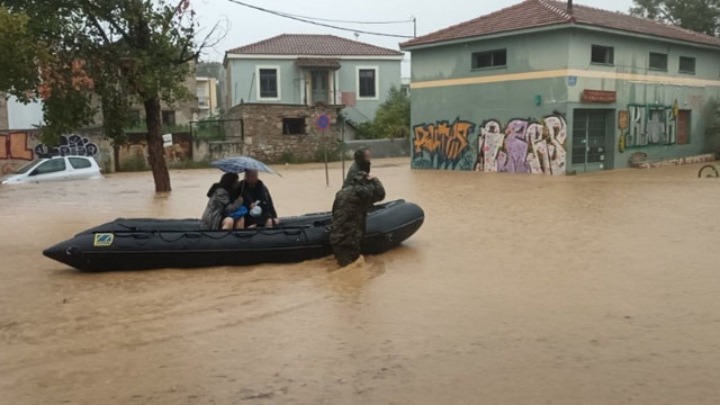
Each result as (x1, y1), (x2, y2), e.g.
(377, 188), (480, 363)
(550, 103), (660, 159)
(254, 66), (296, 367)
(357, 86), (410, 139)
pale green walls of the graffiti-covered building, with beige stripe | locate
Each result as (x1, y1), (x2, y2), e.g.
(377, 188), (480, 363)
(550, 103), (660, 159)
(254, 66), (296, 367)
(411, 29), (720, 174)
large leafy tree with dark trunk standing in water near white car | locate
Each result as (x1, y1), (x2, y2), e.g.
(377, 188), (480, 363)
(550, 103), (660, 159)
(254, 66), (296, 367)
(0, 0), (214, 191)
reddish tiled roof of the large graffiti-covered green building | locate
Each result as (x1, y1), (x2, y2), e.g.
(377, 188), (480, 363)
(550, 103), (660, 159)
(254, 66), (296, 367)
(401, 0), (720, 47)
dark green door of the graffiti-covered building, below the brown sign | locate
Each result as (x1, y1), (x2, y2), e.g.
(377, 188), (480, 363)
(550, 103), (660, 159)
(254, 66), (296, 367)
(572, 110), (614, 172)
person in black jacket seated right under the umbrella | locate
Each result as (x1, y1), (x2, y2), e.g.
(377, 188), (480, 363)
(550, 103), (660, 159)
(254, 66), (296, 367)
(239, 170), (280, 228)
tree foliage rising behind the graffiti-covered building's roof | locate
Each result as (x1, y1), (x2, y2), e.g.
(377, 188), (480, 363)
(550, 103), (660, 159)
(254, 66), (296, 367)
(630, 0), (720, 36)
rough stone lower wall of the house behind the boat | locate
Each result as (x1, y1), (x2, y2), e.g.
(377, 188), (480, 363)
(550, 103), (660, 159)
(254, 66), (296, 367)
(225, 103), (342, 163)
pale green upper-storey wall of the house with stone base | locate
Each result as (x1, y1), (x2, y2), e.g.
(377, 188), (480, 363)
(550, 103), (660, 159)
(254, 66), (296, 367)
(226, 59), (401, 122)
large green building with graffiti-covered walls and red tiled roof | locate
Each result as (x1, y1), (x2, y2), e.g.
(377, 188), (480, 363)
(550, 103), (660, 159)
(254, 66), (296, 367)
(401, 0), (720, 174)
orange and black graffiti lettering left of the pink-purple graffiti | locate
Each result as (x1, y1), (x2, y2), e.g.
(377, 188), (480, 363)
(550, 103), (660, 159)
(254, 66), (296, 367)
(413, 118), (475, 169)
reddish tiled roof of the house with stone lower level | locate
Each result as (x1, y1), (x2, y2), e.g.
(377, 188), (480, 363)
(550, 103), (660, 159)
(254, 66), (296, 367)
(227, 34), (403, 56)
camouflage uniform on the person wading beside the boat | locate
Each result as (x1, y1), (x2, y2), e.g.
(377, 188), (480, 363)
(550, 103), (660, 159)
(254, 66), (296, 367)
(330, 171), (385, 266)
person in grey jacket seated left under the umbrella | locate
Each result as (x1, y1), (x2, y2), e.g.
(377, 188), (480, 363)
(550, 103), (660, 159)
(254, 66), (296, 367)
(202, 173), (247, 230)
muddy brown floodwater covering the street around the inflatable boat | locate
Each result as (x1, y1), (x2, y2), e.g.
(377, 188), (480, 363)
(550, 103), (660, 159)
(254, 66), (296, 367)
(0, 160), (720, 405)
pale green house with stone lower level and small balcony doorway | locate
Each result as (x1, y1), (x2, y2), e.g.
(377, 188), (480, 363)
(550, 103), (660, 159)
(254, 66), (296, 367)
(224, 34), (403, 160)
